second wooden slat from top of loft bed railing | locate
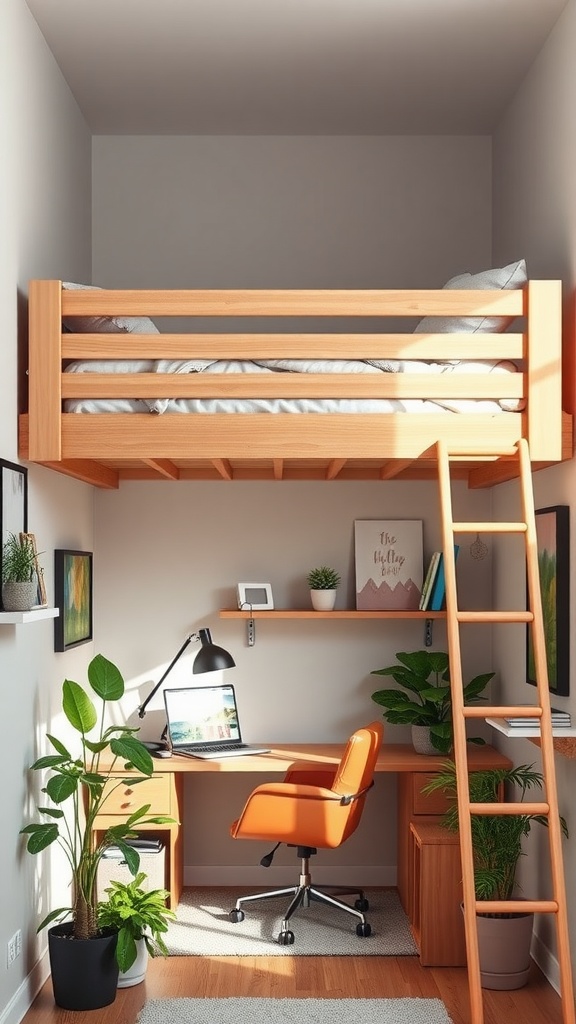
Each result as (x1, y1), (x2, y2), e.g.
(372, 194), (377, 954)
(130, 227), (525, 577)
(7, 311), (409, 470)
(61, 332), (526, 361)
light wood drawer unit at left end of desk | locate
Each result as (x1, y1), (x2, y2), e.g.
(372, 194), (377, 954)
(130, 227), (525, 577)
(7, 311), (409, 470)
(94, 772), (183, 907)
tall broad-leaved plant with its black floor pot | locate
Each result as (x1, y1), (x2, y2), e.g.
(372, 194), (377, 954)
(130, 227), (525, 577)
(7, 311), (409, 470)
(20, 654), (171, 1010)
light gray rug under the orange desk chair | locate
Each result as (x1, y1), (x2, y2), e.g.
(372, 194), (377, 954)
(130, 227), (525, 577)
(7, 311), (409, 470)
(166, 888), (417, 956)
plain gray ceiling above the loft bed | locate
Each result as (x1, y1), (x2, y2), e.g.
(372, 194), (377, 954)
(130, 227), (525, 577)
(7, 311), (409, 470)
(27, 0), (568, 135)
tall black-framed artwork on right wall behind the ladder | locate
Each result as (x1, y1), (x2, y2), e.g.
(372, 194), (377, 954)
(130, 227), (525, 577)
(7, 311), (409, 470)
(526, 505), (570, 696)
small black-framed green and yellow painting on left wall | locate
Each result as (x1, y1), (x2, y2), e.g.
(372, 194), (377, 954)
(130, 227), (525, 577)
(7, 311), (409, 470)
(54, 549), (92, 651)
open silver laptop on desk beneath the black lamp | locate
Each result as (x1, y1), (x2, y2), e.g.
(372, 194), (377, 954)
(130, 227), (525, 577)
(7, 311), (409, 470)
(164, 683), (270, 760)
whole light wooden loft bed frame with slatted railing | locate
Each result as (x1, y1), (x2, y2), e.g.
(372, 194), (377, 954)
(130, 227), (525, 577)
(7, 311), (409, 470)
(19, 281), (572, 487)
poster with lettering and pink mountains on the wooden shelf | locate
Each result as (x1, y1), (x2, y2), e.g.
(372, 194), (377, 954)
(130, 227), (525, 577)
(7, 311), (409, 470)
(354, 519), (423, 611)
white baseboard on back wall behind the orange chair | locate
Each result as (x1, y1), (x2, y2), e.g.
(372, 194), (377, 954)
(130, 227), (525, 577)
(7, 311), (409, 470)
(182, 864), (396, 888)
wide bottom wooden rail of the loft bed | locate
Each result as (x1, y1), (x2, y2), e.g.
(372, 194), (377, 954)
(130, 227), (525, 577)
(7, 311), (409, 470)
(47, 413), (521, 461)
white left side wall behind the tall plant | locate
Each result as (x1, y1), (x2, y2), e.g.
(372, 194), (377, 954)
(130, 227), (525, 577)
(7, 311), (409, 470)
(0, 0), (93, 1024)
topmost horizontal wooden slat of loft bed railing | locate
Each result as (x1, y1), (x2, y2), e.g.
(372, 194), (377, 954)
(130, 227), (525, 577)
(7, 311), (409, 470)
(61, 289), (525, 316)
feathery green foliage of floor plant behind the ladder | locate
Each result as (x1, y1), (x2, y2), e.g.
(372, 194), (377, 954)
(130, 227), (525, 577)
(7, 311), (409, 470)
(423, 761), (568, 918)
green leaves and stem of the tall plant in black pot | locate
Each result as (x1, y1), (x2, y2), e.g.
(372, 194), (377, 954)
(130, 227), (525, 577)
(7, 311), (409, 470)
(20, 654), (172, 939)
